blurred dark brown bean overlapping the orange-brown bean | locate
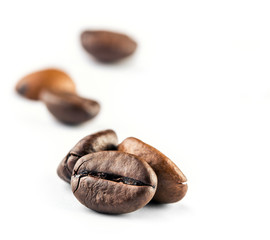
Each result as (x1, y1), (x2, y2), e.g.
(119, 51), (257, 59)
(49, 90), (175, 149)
(40, 90), (100, 125)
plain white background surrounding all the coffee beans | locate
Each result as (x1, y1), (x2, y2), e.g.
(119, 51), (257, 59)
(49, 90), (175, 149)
(0, 0), (270, 240)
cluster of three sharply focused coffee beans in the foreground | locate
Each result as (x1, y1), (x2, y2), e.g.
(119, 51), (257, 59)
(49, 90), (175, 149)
(57, 130), (187, 214)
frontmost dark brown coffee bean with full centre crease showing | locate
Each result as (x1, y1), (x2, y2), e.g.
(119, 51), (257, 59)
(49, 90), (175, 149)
(71, 151), (157, 214)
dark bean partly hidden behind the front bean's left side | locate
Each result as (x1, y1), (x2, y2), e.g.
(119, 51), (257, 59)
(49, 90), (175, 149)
(57, 130), (118, 183)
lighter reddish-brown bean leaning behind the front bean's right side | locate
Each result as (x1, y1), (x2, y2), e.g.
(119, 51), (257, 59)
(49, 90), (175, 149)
(118, 137), (187, 203)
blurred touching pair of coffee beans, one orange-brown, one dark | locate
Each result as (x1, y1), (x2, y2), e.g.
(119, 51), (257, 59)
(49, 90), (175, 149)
(16, 69), (100, 125)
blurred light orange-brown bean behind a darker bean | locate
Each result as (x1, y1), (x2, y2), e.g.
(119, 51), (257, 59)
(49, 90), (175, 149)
(16, 69), (76, 100)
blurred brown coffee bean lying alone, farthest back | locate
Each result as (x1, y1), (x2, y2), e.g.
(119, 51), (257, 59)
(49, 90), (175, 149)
(81, 31), (137, 62)
